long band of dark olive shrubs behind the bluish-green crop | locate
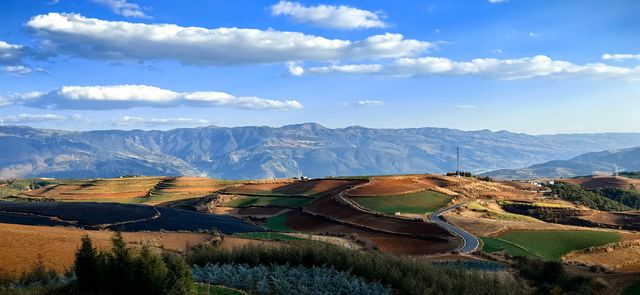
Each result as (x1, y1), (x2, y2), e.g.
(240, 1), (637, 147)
(187, 241), (522, 294)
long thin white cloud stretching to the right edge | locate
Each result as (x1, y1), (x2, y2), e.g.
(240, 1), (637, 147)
(292, 55), (640, 80)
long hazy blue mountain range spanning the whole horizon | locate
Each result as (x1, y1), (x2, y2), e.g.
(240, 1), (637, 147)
(0, 123), (640, 178)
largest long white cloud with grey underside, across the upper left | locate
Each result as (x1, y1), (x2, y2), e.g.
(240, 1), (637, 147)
(26, 13), (434, 65)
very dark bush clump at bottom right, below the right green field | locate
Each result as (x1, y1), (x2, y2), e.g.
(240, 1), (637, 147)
(515, 257), (605, 295)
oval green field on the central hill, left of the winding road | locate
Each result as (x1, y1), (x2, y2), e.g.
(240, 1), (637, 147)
(353, 190), (452, 214)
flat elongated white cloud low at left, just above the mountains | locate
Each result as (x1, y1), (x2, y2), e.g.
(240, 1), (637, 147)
(3, 85), (302, 110)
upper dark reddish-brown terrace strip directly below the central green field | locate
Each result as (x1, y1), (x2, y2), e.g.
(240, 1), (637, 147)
(305, 196), (452, 238)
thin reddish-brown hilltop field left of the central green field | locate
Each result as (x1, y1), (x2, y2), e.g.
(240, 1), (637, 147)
(228, 179), (362, 196)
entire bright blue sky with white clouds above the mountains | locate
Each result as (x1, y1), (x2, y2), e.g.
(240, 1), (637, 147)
(0, 0), (640, 134)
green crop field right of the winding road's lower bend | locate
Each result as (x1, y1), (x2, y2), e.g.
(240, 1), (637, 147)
(481, 230), (621, 260)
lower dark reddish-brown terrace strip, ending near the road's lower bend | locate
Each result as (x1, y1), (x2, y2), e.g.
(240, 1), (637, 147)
(285, 210), (458, 255)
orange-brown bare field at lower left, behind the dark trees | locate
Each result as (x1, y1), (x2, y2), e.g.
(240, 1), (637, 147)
(0, 223), (214, 275)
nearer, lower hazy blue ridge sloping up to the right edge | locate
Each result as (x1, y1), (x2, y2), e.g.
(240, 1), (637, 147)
(483, 147), (640, 179)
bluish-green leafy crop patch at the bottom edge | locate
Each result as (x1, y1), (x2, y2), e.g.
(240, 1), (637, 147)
(192, 263), (391, 295)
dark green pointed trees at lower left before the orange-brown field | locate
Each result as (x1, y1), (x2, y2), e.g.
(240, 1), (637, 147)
(74, 233), (194, 294)
